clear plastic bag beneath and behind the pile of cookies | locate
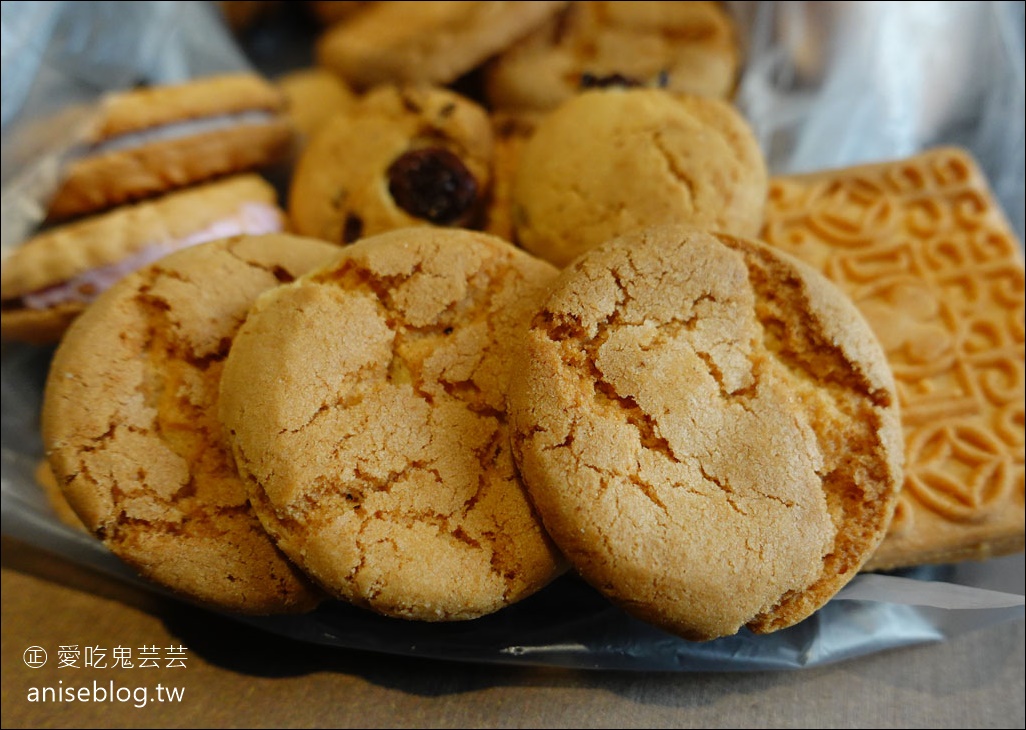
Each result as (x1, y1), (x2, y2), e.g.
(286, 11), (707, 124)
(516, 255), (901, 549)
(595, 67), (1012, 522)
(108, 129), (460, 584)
(2, 2), (1026, 672)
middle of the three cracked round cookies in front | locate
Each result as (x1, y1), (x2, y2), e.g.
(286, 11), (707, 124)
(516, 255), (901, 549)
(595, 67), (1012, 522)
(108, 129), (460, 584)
(221, 227), (564, 621)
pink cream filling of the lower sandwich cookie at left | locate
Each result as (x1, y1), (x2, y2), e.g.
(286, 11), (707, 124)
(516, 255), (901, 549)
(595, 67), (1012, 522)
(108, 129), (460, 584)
(22, 203), (284, 310)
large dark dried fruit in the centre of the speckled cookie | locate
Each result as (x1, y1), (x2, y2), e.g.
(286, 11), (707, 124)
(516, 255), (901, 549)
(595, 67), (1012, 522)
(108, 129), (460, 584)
(388, 147), (477, 226)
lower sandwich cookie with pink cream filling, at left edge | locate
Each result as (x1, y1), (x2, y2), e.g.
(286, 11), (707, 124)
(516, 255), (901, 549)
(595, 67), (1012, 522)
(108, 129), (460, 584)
(0, 173), (285, 343)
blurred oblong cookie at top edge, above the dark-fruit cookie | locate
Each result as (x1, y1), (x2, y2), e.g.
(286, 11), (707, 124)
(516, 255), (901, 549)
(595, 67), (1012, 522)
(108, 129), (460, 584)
(316, 2), (566, 90)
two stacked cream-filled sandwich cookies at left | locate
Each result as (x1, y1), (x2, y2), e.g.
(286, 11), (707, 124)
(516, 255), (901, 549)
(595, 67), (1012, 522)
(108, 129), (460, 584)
(0, 73), (295, 343)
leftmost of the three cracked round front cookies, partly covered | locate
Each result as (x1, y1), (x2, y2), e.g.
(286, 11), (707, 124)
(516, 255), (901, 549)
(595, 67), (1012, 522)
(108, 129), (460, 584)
(42, 235), (338, 614)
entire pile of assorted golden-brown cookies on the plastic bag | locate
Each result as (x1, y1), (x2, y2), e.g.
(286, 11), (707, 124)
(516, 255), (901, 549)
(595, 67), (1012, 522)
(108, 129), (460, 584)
(3, 2), (1024, 641)
